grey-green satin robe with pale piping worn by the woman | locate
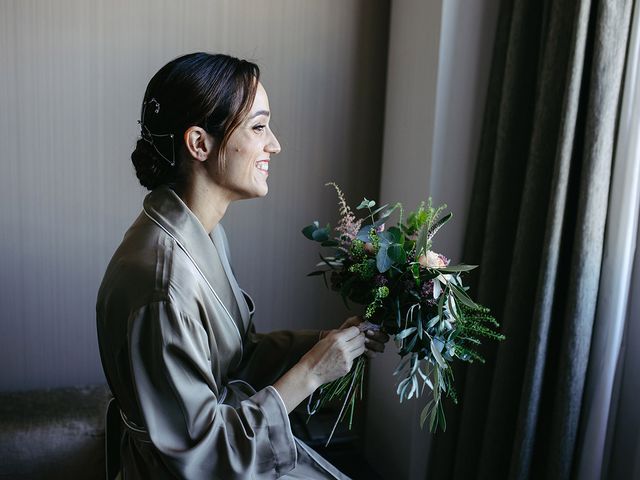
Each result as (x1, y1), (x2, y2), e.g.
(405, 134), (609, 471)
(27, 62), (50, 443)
(96, 187), (347, 480)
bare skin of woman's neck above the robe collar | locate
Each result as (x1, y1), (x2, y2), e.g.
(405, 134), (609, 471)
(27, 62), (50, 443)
(179, 173), (231, 233)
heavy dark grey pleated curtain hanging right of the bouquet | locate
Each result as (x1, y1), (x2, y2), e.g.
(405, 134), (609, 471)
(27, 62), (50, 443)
(428, 0), (633, 479)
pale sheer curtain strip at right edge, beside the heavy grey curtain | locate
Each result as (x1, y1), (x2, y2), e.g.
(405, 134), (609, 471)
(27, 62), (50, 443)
(575, 0), (640, 480)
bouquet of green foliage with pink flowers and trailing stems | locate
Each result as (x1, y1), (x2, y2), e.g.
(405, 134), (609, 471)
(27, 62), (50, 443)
(302, 183), (505, 444)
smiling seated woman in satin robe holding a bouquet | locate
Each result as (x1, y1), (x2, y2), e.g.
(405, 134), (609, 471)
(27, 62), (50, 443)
(96, 53), (388, 479)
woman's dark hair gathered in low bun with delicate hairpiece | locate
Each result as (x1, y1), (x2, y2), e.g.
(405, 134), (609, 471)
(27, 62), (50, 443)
(131, 52), (260, 190)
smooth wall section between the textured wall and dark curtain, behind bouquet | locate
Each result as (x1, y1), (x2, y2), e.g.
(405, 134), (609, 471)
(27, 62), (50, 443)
(366, 0), (499, 480)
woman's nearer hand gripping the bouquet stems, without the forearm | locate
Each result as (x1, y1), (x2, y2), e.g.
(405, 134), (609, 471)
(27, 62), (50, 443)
(300, 326), (365, 386)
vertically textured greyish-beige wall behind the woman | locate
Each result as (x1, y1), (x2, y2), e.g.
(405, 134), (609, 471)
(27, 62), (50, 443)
(0, 0), (389, 390)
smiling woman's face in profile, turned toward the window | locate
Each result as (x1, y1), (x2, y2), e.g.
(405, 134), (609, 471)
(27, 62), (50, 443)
(219, 83), (280, 200)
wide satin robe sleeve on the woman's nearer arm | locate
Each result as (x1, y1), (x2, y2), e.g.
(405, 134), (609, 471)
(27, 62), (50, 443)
(129, 301), (297, 479)
